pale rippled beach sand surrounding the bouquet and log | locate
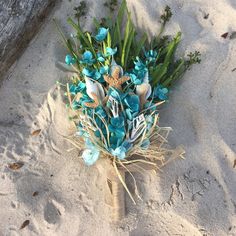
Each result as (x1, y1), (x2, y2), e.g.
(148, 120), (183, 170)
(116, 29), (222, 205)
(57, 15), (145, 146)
(0, 0), (236, 236)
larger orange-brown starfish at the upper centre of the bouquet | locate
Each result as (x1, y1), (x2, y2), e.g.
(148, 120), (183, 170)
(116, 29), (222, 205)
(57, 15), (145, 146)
(104, 66), (130, 90)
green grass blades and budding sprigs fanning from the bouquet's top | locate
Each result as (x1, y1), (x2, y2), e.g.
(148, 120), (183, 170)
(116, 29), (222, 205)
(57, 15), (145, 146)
(56, 0), (200, 87)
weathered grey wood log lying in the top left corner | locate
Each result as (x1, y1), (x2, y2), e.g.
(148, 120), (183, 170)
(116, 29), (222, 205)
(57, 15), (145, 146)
(0, 0), (57, 79)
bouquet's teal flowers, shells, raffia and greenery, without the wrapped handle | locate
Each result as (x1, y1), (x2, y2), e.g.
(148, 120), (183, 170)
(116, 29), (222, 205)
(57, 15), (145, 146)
(54, 0), (200, 219)
